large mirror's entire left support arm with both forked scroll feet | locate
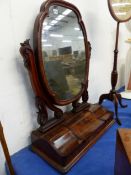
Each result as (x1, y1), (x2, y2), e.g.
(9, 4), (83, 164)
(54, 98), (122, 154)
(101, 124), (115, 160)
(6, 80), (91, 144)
(20, 39), (63, 130)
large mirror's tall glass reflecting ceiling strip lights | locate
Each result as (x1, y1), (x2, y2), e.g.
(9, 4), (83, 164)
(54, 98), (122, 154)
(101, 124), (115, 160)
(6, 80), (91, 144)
(41, 5), (86, 100)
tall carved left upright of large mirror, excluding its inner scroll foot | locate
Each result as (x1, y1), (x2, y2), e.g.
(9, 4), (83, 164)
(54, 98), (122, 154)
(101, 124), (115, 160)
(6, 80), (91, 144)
(20, 40), (48, 127)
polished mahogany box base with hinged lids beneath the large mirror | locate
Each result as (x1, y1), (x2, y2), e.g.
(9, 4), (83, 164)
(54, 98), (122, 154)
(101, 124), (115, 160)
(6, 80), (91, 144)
(31, 104), (114, 173)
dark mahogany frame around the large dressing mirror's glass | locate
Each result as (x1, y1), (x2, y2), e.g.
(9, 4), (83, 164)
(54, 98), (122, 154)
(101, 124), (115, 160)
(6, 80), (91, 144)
(33, 0), (90, 106)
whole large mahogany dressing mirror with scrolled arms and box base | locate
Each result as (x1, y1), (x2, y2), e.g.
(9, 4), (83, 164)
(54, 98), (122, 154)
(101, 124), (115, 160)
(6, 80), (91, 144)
(20, 0), (114, 173)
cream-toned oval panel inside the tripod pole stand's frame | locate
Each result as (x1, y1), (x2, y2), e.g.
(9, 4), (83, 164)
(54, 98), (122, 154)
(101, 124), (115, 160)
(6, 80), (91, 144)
(111, 0), (131, 21)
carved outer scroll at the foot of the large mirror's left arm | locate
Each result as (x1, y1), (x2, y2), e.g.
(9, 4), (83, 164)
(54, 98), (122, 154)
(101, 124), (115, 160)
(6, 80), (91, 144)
(35, 97), (48, 128)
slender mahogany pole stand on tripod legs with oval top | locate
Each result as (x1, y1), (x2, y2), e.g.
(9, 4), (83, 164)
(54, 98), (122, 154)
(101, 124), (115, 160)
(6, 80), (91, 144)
(99, 0), (131, 125)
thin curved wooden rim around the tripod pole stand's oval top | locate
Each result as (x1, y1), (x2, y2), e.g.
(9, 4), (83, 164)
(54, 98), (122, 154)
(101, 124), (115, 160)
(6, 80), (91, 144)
(108, 0), (131, 22)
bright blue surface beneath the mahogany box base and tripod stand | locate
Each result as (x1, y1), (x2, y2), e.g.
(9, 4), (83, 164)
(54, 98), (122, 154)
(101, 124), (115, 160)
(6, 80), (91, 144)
(7, 91), (131, 175)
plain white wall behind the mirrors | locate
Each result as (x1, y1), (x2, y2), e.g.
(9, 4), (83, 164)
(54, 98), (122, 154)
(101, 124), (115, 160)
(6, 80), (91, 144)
(0, 0), (129, 175)
